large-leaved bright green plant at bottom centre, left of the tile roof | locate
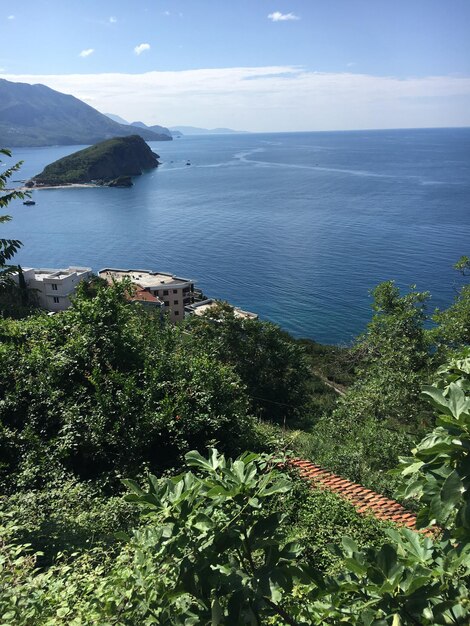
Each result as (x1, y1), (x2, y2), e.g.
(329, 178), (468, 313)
(121, 450), (303, 626)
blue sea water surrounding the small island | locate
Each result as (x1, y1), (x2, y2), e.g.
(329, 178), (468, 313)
(2, 129), (470, 343)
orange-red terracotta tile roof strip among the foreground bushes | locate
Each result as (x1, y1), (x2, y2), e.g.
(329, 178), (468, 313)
(289, 459), (434, 535)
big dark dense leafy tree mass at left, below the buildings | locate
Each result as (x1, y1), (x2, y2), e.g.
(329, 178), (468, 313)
(0, 284), (253, 488)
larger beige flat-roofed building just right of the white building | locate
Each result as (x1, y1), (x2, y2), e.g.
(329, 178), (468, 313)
(98, 268), (194, 323)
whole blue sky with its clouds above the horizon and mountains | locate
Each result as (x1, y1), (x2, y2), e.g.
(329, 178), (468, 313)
(0, 0), (470, 132)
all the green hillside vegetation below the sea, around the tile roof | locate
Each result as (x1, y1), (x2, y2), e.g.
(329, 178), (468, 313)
(0, 150), (470, 626)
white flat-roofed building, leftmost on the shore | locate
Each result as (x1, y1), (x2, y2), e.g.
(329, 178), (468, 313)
(13, 267), (92, 311)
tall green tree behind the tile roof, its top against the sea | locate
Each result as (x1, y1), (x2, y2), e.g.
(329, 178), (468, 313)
(304, 281), (432, 493)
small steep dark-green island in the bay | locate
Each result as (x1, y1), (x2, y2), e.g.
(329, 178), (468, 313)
(25, 135), (159, 188)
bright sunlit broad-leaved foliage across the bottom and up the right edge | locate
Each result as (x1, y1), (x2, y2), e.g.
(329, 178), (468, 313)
(0, 356), (470, 626)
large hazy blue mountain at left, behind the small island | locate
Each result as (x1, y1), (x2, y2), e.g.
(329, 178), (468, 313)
(0, 79), (171, 147)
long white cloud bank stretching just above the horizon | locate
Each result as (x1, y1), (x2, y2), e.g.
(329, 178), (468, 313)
(2, 66), (470, 132)
